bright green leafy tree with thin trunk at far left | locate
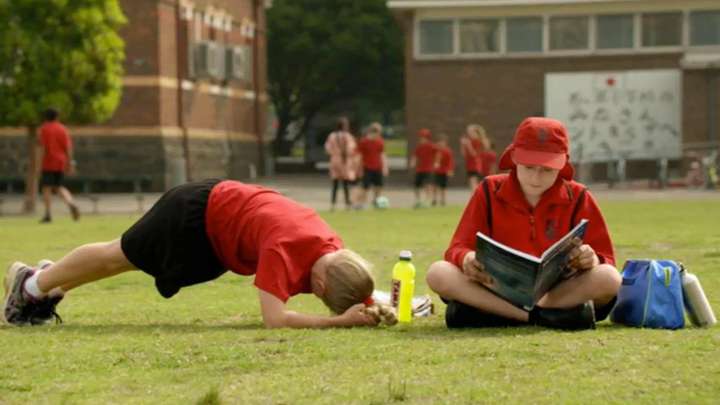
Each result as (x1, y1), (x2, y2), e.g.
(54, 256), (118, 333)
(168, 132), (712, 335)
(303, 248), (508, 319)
(0, 0), (125, 212)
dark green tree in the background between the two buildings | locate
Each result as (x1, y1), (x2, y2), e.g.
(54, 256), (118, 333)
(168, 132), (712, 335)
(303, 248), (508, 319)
(267, 0), (403, 155)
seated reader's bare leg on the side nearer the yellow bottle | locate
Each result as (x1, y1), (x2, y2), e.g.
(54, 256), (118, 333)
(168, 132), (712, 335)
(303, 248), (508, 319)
(426, 260), (528, 322)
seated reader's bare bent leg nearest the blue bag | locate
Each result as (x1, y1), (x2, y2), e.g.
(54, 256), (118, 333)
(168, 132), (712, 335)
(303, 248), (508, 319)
(538, 264), (622, 308)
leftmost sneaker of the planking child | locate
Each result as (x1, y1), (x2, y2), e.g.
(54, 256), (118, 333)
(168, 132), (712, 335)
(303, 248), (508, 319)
(3, 262), (35, 325)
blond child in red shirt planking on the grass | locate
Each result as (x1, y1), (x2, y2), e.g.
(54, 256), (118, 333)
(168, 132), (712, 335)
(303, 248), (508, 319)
(4, 180), (378, 328)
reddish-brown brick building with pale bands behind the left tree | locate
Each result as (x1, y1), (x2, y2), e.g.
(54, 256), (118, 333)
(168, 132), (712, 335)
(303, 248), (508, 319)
(0, 0), (269, 190)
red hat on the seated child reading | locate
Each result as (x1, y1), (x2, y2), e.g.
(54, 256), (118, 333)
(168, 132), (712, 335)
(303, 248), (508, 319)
(498, 117), (575, 180)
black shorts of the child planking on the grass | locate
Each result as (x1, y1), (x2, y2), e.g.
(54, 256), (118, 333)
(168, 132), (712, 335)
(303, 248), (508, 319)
(120, 180), (226, 298)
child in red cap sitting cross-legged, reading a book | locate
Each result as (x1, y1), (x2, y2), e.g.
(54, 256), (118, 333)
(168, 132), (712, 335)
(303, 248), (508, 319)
(427, 117), (622, 329)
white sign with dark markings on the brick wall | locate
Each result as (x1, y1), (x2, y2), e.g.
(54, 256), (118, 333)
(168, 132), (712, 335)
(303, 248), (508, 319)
(545, 70), (682, 162)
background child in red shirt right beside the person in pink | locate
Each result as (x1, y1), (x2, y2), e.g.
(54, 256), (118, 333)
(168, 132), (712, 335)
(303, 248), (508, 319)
(357, 122), (389, 208)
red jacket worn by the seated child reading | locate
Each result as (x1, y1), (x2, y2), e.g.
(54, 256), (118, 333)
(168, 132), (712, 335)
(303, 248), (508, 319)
(445, 170), (615, 267)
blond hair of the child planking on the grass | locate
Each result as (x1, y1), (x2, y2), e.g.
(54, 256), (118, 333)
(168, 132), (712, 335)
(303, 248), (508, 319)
(322, 249), (375, 314)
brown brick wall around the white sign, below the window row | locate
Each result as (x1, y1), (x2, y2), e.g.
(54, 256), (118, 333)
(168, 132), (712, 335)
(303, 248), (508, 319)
(398, 14), (720, 184)
